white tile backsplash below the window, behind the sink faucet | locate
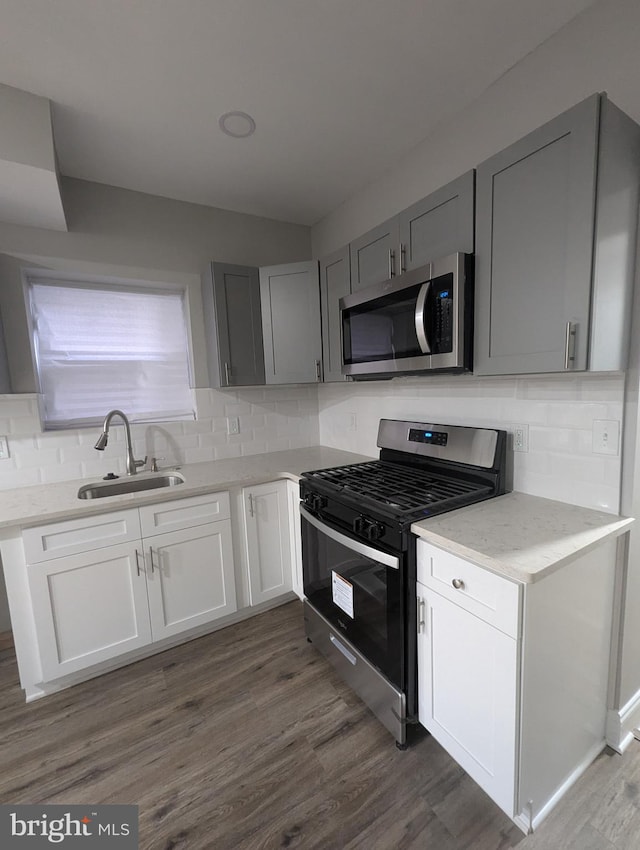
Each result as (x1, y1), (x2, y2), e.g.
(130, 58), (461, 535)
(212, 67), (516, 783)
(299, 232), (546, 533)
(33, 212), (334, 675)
(0, 385), (319, 490)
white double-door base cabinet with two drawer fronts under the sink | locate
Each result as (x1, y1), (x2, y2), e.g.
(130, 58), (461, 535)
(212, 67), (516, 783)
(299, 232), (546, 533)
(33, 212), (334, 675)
(23, 493), (236, 682)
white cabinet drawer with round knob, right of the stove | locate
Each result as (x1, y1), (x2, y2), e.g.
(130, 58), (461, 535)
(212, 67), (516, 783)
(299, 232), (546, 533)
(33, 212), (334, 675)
(417, 540), (520, 637)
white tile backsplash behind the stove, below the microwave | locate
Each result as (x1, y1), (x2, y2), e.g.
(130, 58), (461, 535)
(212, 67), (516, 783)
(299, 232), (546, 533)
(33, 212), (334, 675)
(318, 374), (624, 513)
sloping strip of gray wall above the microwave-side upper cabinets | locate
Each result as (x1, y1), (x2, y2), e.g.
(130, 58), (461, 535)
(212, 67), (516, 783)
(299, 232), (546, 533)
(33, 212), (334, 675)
(312, 0), (640, 257)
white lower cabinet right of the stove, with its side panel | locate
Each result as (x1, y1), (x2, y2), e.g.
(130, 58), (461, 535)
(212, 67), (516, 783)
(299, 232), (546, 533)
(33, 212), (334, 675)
(417, 540), (619, 832)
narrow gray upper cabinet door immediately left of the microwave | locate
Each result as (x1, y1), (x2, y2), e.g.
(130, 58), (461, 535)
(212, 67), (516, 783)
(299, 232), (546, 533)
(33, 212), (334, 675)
(320, 245), (351, 383)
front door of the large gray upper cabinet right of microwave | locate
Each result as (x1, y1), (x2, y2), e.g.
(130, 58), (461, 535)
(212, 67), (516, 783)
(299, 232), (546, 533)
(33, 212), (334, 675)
(474, 95), (600, 375)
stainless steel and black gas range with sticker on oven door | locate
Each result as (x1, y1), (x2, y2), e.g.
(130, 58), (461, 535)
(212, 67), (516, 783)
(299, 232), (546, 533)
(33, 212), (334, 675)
(300, 419), (506, 748)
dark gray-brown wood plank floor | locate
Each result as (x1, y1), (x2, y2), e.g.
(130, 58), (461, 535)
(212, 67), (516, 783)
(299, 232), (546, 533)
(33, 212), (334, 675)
(0, 602), (640, 850)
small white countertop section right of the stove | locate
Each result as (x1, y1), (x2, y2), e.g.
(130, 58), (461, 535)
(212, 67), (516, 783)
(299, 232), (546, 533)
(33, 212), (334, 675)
(411, 493), (634, 583)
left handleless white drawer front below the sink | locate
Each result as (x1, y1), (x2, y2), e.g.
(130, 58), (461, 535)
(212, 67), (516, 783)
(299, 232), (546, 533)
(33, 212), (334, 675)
(22, 509), (140, 564)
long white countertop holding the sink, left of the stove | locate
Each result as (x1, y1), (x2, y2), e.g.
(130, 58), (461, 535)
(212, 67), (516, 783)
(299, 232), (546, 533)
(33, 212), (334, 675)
(0, 446), (371, 529)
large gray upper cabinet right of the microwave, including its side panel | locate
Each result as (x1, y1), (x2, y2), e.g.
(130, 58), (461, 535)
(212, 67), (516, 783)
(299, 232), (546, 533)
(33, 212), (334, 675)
(474, 89), (640, 375)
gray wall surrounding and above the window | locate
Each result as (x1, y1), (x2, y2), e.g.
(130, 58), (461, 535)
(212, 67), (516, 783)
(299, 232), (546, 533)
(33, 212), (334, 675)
(0, 178), (311, 393)
